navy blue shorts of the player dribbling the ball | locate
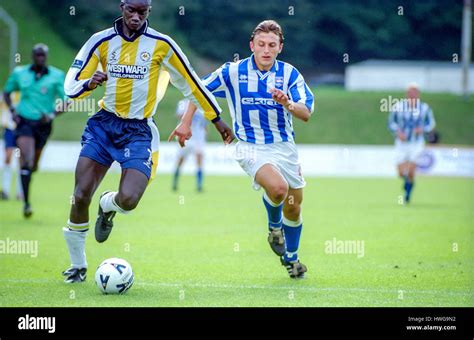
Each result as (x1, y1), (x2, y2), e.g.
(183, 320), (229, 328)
(79, 110), (159, 179)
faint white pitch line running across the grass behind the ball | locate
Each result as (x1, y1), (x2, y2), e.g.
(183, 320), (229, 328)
(0, 279), (474, 297)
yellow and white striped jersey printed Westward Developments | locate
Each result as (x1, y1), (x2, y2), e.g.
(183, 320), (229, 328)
(64, 17), (221, 121)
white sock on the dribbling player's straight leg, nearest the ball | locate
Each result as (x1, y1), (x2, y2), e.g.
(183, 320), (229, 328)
(63, 221), (89, 268)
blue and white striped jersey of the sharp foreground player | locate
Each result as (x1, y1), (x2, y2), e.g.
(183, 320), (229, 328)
(203, 55), (314, 144)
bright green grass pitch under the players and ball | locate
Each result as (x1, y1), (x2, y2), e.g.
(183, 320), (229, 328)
(0, 173), (474, 307)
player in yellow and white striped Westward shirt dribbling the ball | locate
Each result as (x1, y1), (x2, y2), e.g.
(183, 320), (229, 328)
(63, 0), (234, 283)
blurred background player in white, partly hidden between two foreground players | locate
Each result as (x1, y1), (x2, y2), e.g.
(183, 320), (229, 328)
(173, 99), (207, 192)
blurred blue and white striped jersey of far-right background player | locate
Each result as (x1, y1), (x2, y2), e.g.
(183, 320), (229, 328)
(388, 101), (436, 143)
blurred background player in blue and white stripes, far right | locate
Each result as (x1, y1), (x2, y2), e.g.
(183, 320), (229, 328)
(388, 83), (436, 203)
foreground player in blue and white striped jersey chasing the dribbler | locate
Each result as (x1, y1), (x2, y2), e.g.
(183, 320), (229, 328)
(171, 20), (314, 278)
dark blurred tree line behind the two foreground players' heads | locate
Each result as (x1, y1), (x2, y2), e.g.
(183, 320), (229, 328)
(32, 0), (462, 70)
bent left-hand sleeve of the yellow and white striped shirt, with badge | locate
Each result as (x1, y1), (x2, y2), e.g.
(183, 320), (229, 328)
(64, 34), (100, 99)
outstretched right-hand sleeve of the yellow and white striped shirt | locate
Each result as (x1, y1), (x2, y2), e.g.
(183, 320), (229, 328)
(163, 38), (221, 122)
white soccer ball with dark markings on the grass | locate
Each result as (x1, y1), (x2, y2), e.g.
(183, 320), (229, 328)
(95, 257), (134, 294)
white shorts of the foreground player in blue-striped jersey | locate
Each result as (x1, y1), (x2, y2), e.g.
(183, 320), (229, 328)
(235, 141), (306, 190)
